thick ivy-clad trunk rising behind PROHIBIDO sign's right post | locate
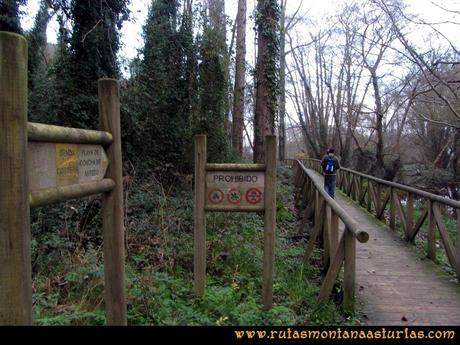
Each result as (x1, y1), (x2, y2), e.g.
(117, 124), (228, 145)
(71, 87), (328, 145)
(254, 0), (279, 163)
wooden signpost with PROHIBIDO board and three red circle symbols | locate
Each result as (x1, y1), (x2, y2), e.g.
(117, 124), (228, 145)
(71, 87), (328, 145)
(194, 135), (277, 309)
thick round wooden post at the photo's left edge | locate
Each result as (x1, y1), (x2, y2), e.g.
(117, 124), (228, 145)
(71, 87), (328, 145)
(0, 32), (33, 325)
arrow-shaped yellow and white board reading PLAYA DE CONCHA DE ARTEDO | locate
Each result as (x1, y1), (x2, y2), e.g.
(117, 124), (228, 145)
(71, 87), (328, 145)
(28, 142), (109, 191)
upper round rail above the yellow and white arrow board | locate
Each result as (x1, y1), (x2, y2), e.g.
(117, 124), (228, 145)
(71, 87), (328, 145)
(27, 122), (113, 145)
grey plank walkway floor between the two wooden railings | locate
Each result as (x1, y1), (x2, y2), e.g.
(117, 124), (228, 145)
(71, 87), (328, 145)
(310, 170), (460, 326)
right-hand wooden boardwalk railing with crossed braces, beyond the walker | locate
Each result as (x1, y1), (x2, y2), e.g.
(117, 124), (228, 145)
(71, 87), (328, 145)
(304, 159), (460, 279)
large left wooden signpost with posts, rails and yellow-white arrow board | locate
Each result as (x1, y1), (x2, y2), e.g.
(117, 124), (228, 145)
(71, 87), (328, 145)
(0, 32), (127, 325)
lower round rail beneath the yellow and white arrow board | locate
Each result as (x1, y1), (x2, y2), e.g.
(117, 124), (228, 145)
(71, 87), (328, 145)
(29, 178), (115, 207)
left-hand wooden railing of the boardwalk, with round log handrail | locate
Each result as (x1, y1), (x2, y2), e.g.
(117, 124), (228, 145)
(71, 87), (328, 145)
(293, 160), (369, 311)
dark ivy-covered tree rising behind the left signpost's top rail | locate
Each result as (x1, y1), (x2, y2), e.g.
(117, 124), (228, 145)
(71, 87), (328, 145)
(56, 0), (128, 129)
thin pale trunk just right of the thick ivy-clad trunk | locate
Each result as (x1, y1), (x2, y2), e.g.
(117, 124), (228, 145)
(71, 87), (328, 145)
(278, 0), (287, 161)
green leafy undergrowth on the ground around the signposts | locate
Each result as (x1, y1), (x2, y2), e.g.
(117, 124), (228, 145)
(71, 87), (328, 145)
(32, 168), (355, 325)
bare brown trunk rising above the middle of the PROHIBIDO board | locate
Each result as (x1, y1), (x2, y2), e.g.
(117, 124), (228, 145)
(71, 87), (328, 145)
(232, 0), (246, 158)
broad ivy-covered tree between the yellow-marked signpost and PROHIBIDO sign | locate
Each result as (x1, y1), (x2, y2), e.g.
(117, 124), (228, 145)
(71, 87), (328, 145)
(125, 0), (193, 170)
